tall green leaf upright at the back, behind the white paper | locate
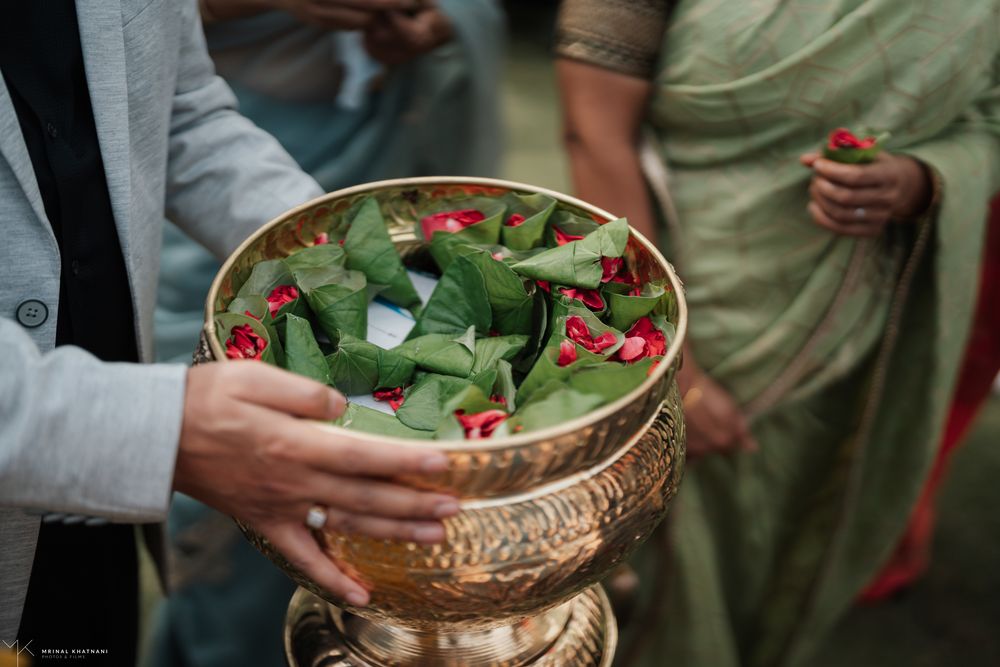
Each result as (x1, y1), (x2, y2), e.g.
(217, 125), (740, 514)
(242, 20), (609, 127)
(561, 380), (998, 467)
(344, 197), (420, 308)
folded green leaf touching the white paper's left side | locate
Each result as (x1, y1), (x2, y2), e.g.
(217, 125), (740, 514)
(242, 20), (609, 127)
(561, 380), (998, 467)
(292, 266), (368, 342)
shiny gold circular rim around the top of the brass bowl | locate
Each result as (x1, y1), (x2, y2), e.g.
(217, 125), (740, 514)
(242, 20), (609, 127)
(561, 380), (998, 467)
(204, 176), (688, 453)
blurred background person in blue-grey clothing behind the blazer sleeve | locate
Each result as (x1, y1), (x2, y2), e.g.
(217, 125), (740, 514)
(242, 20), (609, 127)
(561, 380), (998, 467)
(150, 0), (504, 667)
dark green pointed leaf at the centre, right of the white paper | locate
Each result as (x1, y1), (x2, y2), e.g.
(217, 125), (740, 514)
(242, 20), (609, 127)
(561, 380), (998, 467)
(407, 257), (493, 340)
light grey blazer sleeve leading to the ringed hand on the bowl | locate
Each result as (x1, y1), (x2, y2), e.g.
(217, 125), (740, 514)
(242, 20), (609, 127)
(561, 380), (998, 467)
(0, 318), (186, 522)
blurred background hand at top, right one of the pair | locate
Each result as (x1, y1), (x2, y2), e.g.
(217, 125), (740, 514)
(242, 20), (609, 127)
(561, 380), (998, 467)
(365, 0), (453, 65)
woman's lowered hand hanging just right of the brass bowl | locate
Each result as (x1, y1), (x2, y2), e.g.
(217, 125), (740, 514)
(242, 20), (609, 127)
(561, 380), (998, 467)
(677, 352), (758, 460)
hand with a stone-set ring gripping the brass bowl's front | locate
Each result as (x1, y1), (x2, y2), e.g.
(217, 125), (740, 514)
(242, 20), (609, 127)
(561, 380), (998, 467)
(174, 361), (459, 606)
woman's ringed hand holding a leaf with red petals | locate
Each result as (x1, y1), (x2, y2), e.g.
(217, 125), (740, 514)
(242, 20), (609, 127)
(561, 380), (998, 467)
(800, 153), (933, 236)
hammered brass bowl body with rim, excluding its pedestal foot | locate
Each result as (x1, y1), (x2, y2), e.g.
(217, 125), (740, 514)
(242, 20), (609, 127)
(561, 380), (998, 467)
(199, 177), (687, 664)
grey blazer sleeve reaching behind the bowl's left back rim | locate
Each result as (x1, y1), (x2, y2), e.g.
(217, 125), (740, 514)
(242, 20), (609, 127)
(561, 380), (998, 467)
(166, 2), (323, 257)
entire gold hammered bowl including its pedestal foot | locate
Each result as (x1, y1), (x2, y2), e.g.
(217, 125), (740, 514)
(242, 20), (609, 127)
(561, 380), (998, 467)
(198, 177), (687, 667)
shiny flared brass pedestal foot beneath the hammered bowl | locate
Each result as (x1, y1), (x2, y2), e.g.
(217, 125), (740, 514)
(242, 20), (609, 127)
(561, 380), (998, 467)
(285, 586), (618, 667)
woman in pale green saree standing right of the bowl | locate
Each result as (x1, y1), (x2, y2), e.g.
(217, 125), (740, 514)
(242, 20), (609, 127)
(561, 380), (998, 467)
(557, 0), (1000, 667)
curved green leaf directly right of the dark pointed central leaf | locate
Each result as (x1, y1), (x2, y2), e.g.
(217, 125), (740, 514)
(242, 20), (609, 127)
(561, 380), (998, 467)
(462, 250), (536, 335)
